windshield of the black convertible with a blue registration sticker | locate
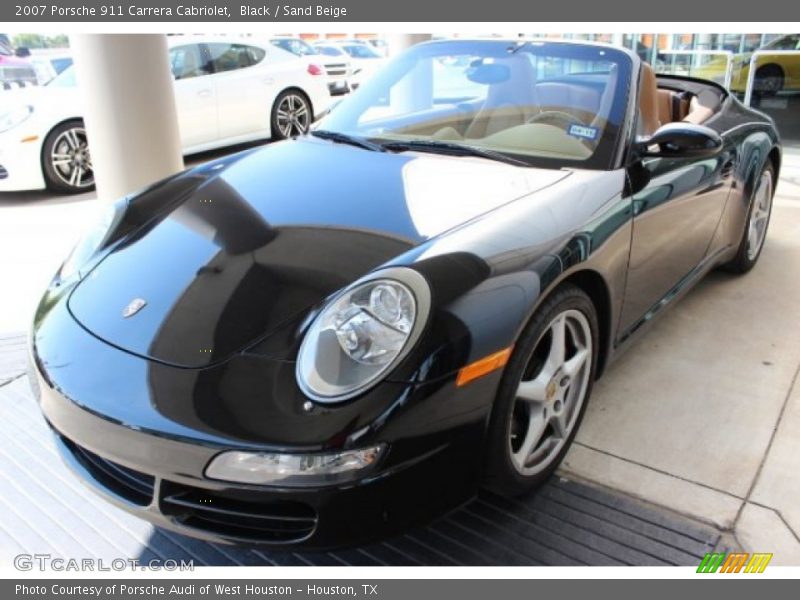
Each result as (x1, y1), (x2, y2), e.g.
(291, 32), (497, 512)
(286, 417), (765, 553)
(319, 40), (631, 169)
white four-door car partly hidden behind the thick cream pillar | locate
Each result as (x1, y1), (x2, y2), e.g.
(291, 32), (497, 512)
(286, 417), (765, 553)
(0, 36), (331, 193)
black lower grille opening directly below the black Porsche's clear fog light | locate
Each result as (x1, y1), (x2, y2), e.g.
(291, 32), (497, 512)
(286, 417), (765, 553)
(160, 482), (317, 544)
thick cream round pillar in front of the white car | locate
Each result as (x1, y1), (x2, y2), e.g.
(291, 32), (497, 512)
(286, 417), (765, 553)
(70, 34), (183, 200)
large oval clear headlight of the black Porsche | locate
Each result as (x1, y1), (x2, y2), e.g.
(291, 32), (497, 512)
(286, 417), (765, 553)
(297, 268), (430, 402)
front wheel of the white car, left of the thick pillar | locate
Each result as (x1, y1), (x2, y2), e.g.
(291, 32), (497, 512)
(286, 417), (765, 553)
(41, 119), (94, 194)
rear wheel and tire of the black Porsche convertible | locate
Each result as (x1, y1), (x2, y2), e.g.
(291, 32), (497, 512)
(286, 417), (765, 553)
(724, 161), (775, 274)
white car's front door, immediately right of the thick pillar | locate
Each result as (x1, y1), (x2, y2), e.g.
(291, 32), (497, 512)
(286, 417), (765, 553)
(169, 44), (219, 150)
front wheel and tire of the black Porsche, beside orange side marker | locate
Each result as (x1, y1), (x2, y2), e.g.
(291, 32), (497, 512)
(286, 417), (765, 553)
(484, 284), (598, 496)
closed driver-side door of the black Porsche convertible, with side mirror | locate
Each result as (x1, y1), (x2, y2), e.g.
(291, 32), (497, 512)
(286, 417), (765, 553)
(619, 108), (734, 337)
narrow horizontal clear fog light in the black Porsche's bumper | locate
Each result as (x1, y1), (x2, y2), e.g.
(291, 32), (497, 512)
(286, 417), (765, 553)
(206, 444), (386, 487)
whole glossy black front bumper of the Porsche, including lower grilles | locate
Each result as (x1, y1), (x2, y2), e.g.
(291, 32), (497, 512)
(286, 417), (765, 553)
(32, 288), (496, 550)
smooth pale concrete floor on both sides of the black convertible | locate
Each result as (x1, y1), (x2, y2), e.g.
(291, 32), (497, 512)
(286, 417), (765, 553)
(0, 150), (800, 565)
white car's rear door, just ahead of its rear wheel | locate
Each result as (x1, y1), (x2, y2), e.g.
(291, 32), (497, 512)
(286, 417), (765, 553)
(206, 42), (276, 140)
